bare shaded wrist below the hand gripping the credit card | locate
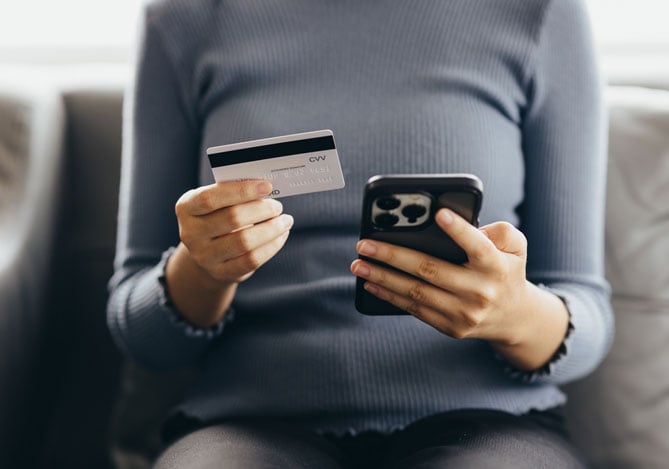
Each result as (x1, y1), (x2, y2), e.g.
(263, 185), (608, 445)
(165, 243), (237, 327)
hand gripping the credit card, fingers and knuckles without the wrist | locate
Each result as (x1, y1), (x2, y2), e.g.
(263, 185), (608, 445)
(175, 180), (293, 284)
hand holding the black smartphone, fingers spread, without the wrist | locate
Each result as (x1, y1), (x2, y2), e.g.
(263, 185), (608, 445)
(351, 209), (536, 345)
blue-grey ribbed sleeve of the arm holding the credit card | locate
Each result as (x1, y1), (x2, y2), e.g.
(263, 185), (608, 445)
(107, 9), (231, 369)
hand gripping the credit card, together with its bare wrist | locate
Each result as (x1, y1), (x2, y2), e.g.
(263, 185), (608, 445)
(165, 180), (293, 327)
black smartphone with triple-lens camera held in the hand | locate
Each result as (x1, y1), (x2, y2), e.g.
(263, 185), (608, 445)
(355, 174), (483, 315)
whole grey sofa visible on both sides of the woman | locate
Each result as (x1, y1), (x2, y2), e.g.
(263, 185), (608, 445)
(0, 66), (669, 469)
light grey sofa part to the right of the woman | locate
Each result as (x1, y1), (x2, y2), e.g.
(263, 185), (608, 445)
(567, 87), (669, 468)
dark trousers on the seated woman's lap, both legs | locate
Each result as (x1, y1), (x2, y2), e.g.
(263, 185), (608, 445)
(154, 409), (586, 469)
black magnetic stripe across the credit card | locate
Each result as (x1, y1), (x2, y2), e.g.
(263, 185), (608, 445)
(209, 135), (335, 168)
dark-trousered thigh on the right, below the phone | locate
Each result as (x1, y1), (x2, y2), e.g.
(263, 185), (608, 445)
(382, 410), (585, 469)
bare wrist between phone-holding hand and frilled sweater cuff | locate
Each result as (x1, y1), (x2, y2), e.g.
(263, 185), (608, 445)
(491, 281), (569, 371)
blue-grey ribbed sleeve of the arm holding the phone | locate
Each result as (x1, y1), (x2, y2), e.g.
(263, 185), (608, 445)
(519, 0), (613, 384)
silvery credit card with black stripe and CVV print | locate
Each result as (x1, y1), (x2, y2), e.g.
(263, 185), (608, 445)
(207, 130), (345, 198)
